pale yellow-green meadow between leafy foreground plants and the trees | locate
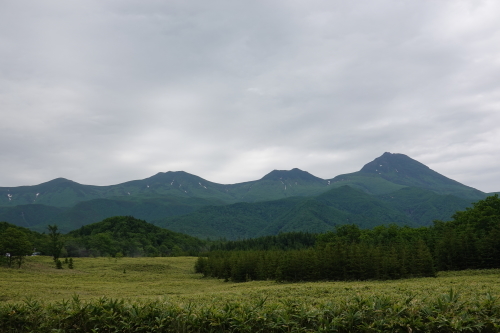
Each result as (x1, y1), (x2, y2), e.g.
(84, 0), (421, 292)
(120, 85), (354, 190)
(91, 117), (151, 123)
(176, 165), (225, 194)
(0, 256), (500, 304)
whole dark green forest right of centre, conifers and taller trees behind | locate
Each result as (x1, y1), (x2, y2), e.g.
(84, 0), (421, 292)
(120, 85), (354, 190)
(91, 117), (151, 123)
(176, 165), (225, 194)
(195, 195), (500, 282)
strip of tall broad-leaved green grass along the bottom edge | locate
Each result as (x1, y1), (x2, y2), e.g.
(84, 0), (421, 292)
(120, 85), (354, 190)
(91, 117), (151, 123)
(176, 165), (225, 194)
(0, 289), (500, 333)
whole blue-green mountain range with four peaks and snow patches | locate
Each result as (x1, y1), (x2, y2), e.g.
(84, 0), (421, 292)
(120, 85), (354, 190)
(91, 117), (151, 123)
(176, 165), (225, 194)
(0, 153), (488, 239)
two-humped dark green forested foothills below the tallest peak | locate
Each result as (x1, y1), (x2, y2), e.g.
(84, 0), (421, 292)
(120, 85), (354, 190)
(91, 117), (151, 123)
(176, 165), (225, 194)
(154, 186), (471, 240)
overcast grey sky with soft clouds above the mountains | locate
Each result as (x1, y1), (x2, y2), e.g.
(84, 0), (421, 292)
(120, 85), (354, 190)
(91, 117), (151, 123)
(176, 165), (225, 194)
(0, 0), (500, 192)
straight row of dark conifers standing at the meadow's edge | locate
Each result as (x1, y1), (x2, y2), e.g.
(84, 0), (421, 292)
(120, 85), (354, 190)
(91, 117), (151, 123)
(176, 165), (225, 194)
(195, 232), (436, 282)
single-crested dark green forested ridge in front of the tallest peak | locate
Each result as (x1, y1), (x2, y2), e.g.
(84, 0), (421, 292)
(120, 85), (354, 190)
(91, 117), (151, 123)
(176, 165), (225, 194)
(155, 186), (426, 239)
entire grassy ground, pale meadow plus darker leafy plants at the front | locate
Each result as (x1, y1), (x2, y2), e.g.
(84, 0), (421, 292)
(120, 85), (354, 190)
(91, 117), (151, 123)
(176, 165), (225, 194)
(0, 257), (500, 332)
